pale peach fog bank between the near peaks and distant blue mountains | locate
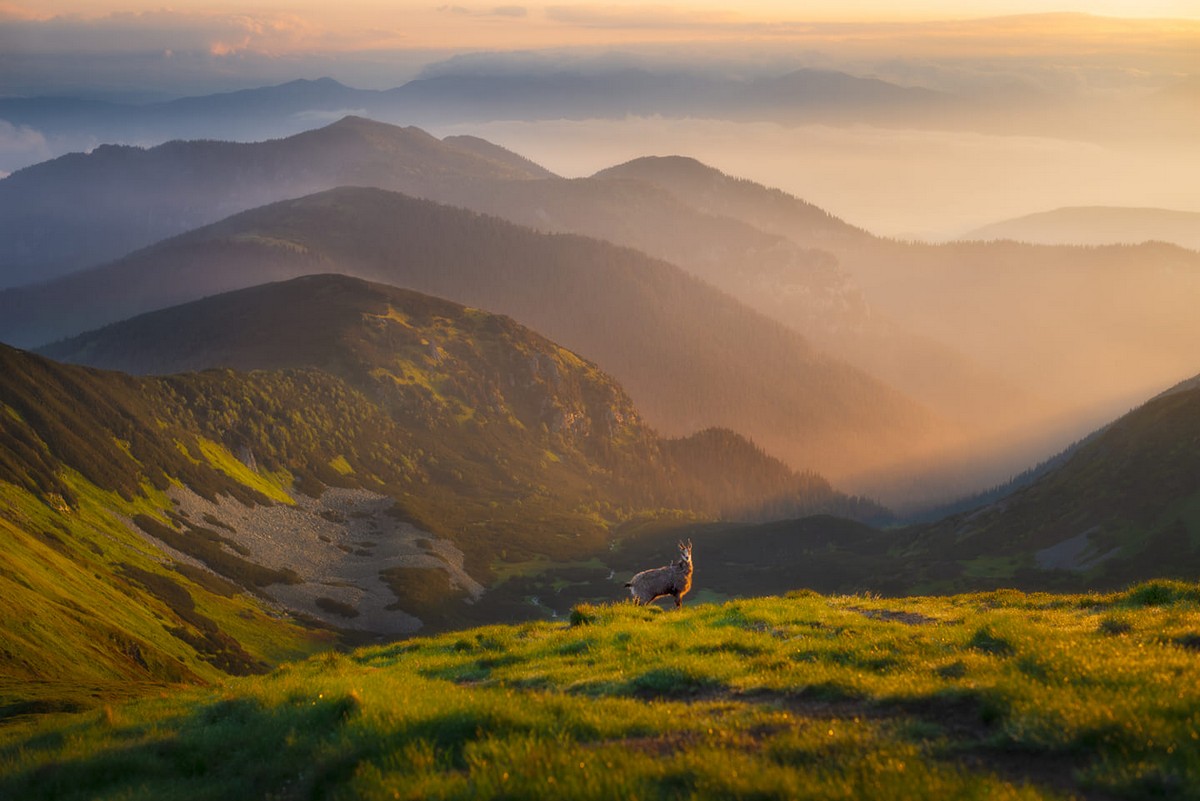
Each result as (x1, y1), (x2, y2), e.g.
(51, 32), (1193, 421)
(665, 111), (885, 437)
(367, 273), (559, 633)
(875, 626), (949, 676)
(434, 118), (1200, 241)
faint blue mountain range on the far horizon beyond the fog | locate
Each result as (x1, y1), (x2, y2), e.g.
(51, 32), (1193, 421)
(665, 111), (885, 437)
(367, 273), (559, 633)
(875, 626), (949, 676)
(0, 70), (954, 171)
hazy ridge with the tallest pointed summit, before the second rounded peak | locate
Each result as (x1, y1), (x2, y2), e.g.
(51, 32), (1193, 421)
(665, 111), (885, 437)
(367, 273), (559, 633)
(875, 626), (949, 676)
(0, 118), (868, 371)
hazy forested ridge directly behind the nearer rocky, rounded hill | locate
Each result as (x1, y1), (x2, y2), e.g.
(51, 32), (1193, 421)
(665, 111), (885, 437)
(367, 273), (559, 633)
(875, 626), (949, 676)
(11, 188), (944, 484)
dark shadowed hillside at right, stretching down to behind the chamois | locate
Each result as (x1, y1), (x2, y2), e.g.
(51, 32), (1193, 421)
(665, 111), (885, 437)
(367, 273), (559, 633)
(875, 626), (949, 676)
(638, 380), (1200, 597)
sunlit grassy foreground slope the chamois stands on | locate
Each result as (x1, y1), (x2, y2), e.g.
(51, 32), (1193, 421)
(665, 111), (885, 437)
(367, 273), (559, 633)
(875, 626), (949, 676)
(0, 582), (1200, 799)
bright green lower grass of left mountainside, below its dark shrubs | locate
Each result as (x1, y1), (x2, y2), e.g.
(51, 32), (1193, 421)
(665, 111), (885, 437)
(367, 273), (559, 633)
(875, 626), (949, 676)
(0, 460), (332, 718)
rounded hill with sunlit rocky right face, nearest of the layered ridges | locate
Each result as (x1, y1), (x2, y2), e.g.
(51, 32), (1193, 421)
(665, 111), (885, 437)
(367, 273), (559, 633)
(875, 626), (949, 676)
(42, 275), (877, 527)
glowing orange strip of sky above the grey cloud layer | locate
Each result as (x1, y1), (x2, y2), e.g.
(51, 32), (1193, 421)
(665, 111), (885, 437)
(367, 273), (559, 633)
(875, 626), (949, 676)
(7, 0), (1200, 56)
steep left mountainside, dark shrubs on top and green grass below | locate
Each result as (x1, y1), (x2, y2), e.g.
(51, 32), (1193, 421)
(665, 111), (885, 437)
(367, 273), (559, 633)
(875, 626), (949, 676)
(0, 345), (332, 717)
